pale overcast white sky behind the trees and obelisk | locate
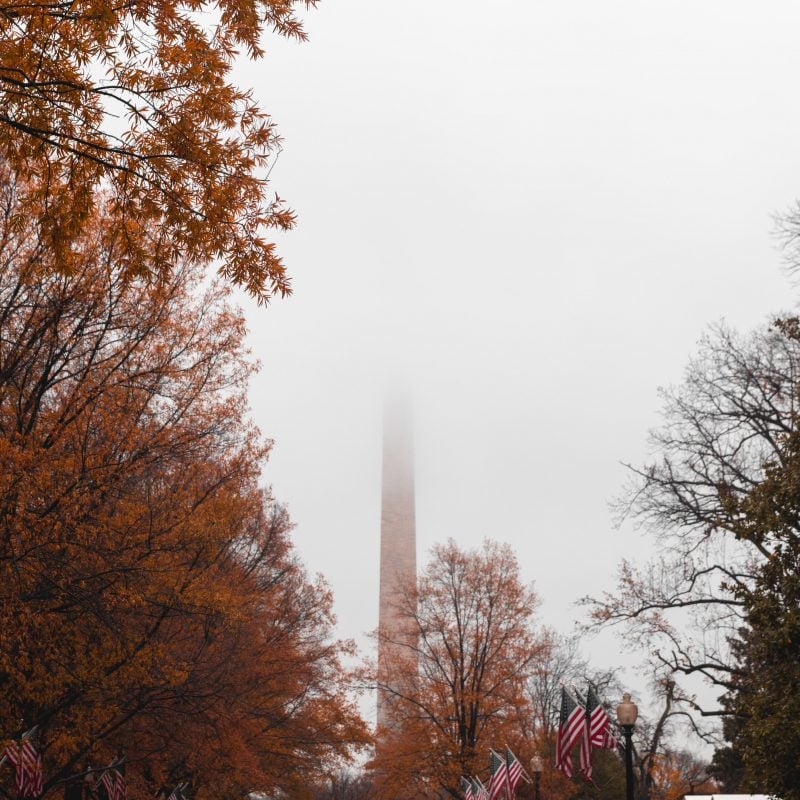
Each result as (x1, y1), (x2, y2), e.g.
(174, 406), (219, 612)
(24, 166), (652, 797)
(234, 0), (800, 720)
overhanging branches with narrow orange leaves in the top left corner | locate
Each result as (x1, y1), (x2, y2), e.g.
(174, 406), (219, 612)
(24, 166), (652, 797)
(0, 0), (316, 301)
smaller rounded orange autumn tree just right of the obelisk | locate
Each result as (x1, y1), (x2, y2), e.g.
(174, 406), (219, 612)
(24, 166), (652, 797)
(370, 540), (543, 798)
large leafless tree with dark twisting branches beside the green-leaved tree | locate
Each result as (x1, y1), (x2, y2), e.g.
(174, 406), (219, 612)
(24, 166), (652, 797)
(584, 322), (800, 715)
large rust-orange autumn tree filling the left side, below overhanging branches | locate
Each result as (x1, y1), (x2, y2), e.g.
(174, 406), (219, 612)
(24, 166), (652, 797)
(0, 171), (366, 800)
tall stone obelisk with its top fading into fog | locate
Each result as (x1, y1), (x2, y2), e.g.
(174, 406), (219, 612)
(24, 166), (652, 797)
(378, 396), (417, 728)
